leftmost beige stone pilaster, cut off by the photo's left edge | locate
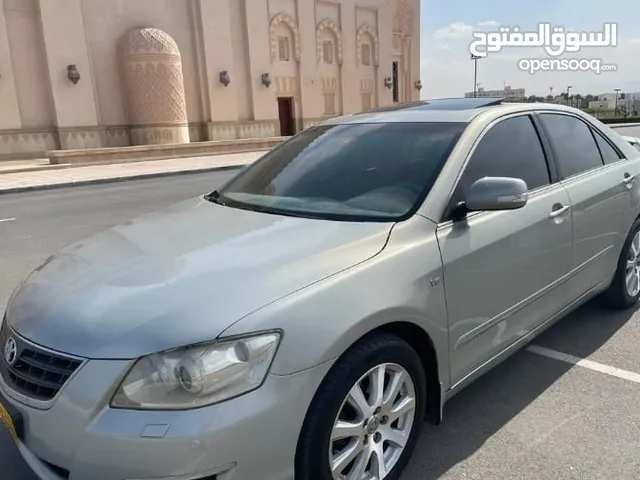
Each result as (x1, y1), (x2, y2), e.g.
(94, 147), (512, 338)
(0, 0), (22, 130)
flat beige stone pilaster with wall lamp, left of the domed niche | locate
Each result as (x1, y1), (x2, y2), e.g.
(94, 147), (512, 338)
(40, 0), (103, 149)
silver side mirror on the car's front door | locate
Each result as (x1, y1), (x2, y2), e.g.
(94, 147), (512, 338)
(464, 177), (529, 212)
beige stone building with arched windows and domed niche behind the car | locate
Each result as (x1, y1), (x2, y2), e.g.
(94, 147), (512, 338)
(0, 0), (421, 158)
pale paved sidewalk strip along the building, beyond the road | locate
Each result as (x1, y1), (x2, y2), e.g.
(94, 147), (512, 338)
(0, 151), (265, 194)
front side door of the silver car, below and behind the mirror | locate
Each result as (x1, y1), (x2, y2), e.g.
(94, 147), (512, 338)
(437, 115), (571, 384)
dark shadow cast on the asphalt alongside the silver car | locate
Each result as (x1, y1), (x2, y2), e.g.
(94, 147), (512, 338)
(402, 301), (635, 480)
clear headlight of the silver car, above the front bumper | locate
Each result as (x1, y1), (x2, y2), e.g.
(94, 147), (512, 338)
(111, 332), (280, 410)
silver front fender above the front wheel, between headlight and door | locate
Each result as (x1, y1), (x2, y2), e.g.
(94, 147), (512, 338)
(222, 217), (449, 388)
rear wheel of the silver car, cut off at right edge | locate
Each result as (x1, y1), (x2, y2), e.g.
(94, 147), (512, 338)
(603, 219), (640, 310)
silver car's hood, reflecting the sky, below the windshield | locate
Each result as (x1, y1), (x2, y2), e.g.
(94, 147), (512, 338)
(7, 198), (391, 359)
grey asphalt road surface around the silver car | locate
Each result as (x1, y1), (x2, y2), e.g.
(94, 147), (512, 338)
(0, 172), (640, 480)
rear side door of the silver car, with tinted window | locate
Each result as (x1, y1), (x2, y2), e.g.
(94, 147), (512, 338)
(540, 113), (638, 300)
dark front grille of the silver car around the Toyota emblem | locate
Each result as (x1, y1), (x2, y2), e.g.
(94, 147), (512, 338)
(0, 321), (82, 402)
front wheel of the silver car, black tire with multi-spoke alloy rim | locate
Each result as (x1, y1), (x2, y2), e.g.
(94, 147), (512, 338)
(295, 334), (426, 480)
